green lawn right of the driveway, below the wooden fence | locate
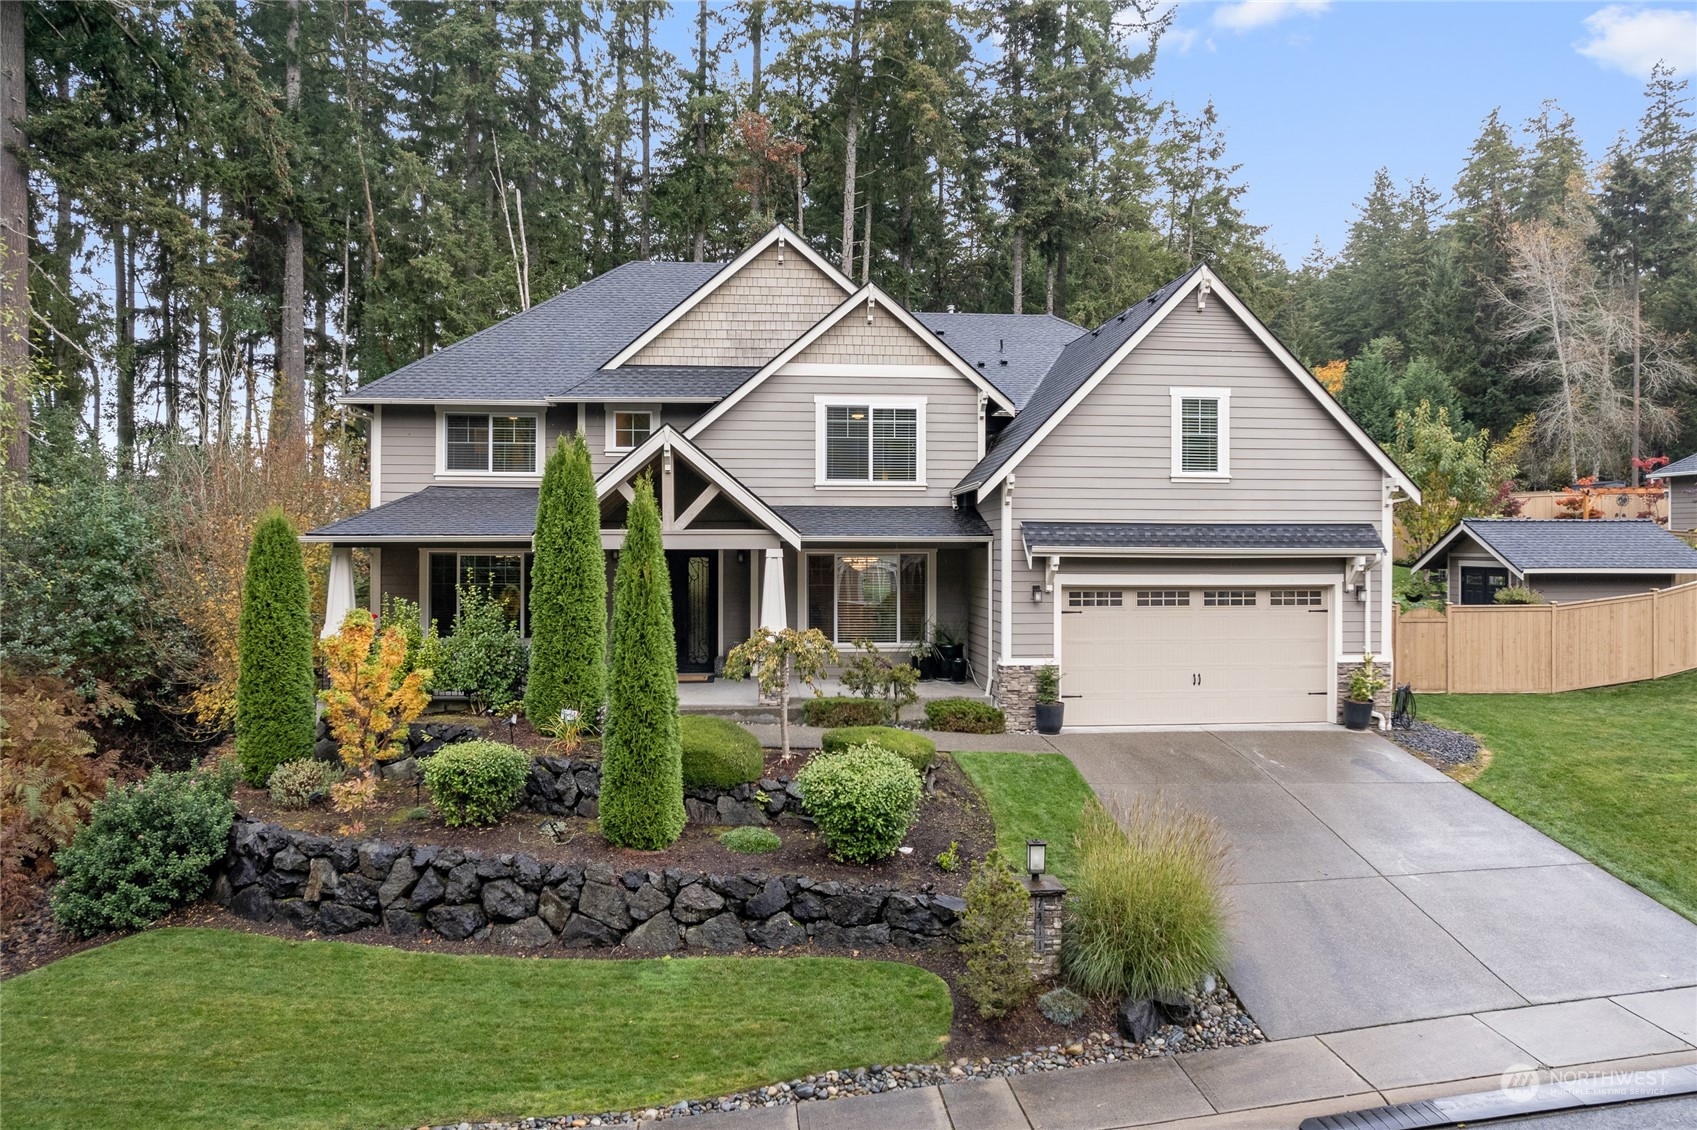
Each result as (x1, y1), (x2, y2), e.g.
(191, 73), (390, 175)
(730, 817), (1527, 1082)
(1419, 672), (1697, 921)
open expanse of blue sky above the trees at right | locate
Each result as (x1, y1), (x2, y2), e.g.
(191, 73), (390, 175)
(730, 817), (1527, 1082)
(1151, 0), (1697, 265)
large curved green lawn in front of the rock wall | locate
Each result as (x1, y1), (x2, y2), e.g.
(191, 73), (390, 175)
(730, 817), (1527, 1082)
(0, 930), (952, 1130)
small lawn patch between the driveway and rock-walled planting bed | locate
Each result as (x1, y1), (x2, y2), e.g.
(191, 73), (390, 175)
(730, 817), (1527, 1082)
(952, 753), (1095, 882)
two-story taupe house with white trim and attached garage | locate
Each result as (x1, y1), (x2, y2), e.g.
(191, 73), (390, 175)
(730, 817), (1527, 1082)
(307, 227), (1415, 726)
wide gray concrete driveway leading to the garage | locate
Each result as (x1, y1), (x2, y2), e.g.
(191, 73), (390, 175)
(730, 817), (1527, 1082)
(1050, 728), (1697, 1038)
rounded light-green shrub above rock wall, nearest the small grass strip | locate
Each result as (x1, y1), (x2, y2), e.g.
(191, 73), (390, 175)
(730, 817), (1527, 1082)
(796, 745), (925, 864)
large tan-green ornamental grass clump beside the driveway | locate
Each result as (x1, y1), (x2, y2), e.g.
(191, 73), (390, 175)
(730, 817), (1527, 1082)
(1061, 790), (1225, 999)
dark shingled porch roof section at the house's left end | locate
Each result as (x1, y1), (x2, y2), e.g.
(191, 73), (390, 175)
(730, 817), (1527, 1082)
(300, 487), (536, 545)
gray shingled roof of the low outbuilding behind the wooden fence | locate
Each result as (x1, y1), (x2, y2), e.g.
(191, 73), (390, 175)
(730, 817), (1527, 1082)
(1414, 517), (1697, 573)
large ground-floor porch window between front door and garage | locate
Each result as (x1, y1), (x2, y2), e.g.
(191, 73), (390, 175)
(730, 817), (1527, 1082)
(808, 553), (930, 643)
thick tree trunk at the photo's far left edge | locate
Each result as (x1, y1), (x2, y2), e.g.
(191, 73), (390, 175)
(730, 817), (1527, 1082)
(0, 0), (29, 475)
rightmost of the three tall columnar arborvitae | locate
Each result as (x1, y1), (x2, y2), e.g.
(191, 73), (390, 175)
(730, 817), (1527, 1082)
(601, 478), (684, 852)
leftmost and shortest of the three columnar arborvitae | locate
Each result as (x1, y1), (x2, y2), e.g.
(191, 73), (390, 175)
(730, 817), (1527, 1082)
(236, 511), (316, 786)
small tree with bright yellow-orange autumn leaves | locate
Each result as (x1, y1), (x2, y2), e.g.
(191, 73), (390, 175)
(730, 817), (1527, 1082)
(319, 607), (431, 835)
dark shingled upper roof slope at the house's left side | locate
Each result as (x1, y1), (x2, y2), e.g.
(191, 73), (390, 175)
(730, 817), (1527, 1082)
(346, 260), (725, 404)
